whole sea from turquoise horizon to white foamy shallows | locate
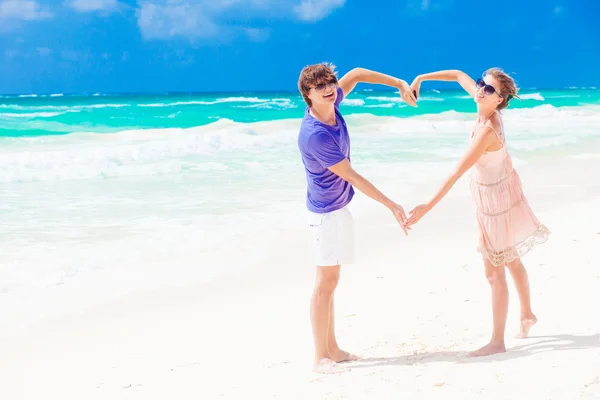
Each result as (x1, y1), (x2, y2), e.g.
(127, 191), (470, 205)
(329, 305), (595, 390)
(0, 87), (600, 296)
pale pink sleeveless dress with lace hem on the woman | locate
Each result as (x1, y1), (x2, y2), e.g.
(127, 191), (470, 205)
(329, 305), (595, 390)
(469, 111), (550, 266)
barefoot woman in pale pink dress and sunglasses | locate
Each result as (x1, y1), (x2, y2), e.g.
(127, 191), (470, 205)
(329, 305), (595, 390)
(407, 68), (550, 357)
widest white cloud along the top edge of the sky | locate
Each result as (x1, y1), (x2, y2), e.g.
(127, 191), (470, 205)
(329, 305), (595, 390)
(137, 0), (345, 41)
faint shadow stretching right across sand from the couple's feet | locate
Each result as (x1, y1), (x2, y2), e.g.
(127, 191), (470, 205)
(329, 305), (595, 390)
(352, 334), (600, 369)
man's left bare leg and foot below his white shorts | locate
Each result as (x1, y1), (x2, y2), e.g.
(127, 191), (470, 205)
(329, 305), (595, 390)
(310, 265), (340, 373)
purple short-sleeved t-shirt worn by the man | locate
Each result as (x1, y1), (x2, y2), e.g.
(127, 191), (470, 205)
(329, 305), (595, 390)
(298, 87), (354, 214)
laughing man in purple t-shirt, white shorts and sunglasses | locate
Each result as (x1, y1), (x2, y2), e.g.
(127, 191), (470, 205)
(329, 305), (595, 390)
(298, 64), (416, 373)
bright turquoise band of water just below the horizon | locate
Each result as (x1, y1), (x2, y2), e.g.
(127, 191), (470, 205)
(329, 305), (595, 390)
(0, 88), (600, 137)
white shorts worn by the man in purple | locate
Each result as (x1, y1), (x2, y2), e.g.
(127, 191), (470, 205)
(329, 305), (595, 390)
(309, 207), (354, 267)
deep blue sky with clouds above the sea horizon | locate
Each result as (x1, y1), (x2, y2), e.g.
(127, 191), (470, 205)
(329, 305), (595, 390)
(0, 0), (600, 93)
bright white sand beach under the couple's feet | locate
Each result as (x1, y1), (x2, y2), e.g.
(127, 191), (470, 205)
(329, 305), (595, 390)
(0, 158), (600, 400)
